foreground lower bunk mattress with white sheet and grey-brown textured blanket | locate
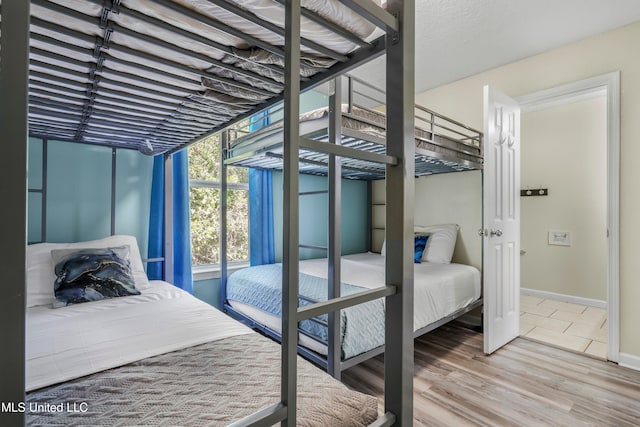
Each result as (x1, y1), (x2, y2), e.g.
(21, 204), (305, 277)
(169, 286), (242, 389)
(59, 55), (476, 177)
(25, 282), (377, 426)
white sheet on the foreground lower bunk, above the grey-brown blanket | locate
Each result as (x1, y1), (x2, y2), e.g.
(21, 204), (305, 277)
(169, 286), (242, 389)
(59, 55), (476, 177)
(26, 281), (253, 391)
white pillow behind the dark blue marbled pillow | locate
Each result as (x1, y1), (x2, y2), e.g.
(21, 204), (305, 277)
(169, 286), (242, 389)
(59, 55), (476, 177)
(26, 236), (150, 307)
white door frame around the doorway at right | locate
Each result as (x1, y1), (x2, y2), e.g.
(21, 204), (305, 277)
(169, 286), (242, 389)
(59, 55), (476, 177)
(515, 71), (620, 362)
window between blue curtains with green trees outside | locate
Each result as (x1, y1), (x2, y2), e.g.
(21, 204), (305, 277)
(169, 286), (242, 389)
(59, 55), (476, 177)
(189, 134), (249, 266)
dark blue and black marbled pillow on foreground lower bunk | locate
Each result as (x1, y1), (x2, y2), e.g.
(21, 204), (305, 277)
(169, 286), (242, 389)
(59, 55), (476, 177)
(51, 246), (140, 308)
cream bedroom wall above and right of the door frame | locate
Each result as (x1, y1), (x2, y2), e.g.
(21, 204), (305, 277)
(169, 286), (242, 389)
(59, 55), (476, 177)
(416, 23), (640, 362)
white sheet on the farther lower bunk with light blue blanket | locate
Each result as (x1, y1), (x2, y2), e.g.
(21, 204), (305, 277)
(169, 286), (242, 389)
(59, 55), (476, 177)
(230, 252), (481, 354)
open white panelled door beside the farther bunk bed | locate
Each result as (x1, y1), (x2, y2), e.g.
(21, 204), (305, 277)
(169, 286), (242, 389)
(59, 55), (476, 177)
(481, 86), (520, 354)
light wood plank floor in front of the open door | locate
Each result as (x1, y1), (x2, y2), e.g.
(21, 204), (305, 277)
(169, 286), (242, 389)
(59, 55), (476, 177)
(343, 324), (640, 427)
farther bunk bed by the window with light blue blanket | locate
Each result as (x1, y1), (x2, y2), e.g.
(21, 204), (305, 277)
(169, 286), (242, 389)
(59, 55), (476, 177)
(222, 75), (483, 378)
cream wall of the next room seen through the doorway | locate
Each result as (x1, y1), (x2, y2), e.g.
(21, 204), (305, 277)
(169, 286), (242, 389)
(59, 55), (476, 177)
(520, 95), (607, 301)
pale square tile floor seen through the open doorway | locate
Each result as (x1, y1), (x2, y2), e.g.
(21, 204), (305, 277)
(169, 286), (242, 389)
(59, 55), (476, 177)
(520, 295), (607, 359)
